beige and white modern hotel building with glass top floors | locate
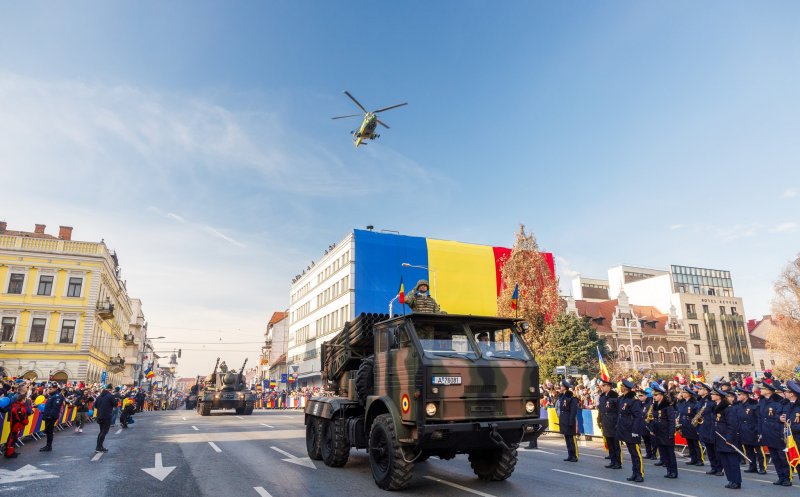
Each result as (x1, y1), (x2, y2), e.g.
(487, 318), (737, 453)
(572, 265), (755, 377)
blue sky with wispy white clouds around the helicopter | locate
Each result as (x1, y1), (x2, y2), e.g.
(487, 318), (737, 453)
(0, 1), (800, 374)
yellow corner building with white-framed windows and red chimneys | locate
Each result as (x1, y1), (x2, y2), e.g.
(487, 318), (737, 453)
(0, 222), (137, 384)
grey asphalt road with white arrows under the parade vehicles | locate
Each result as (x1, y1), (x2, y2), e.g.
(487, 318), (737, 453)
(0, 411), (800, 497)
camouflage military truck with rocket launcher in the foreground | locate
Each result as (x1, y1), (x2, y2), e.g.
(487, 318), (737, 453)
(305, 314), (547, 490)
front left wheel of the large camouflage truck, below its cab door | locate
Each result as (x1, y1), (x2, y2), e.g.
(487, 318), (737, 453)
(369, 414), (414, 490)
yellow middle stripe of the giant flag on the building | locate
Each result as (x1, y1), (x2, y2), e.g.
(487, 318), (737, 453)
(427, 238), (497, 316)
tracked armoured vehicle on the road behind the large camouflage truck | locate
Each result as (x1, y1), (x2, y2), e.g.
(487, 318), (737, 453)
(197, 357), (255, 416)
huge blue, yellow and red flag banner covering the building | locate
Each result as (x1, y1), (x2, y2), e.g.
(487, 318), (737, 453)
(353, 230), (555, 316)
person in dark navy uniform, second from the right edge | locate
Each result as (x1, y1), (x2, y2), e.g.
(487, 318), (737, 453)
(758, 380), (792, 487)
